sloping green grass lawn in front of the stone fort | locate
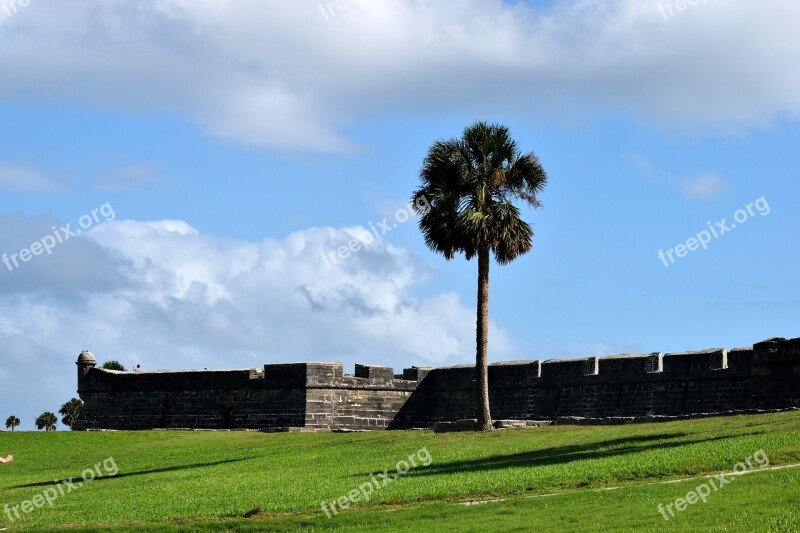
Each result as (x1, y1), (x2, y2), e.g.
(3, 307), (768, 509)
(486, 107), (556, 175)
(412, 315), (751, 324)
(0, 412), (800, 532)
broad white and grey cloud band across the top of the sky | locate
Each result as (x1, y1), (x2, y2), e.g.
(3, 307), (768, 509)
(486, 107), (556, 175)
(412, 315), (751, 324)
(0, 0), (800, 151)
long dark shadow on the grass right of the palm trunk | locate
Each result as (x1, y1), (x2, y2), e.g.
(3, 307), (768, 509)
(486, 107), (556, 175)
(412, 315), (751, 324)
(356, 433), (764, 477)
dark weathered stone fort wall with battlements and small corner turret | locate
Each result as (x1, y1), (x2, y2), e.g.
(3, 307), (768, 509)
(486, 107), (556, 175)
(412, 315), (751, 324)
(76, 339), (800, 430)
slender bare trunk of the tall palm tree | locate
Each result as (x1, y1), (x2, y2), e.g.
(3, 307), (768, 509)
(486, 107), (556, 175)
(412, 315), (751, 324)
(475, 249), (494, 431)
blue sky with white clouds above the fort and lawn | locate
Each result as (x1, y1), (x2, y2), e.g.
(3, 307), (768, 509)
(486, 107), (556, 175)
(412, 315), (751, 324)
(0, 0), (800, 429)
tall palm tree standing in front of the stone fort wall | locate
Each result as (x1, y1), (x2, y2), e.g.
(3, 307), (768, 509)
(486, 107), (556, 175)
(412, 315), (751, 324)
(412, 122), (547, 430)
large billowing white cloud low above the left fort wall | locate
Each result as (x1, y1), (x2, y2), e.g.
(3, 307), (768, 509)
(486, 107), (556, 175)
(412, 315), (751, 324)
(0, 215), (522, 424)
